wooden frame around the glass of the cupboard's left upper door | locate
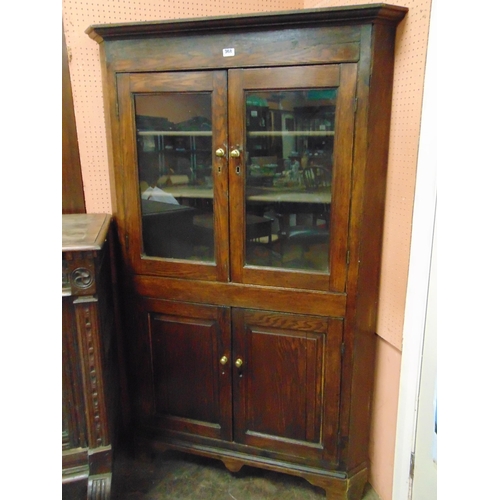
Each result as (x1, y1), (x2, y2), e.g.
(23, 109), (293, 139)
(118, 72), (229, 281)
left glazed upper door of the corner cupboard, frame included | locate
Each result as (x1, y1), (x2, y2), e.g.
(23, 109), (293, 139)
(117, 71), (229, 281)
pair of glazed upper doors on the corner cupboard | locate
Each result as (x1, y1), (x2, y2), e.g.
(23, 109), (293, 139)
(117, 63), (357, 292)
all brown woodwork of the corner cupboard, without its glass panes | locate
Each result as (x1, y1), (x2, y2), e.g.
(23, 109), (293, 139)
(87, 4), (407, 500)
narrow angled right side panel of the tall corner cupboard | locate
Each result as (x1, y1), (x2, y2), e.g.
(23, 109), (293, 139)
(345, 25), (395, 469)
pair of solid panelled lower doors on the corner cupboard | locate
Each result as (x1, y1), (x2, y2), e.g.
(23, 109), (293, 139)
(138, 299), (343, 467)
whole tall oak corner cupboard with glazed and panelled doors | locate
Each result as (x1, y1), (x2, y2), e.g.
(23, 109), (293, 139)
(87, 4), (407, 499)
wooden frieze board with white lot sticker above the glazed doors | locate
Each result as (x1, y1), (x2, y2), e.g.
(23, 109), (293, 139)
(98, 27), (359, 72)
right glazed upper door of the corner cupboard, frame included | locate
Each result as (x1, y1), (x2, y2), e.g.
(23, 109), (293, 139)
(228, 63), (357, 292)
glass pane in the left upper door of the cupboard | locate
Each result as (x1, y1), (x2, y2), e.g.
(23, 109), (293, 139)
(135, 92), (214, 262)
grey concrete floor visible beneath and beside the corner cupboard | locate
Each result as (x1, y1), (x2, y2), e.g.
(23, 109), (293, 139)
(111, 451), (380, 500)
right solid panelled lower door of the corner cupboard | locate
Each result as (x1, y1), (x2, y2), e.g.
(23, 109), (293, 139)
(233, 309), (342, 464)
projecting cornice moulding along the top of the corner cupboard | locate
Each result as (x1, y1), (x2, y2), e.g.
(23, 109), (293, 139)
(85, 4), (408, 43)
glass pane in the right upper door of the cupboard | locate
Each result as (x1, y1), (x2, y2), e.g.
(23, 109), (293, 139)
(245, 88), (337, 272)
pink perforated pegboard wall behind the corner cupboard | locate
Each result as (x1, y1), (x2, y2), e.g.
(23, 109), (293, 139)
(63, 0), (431, 500)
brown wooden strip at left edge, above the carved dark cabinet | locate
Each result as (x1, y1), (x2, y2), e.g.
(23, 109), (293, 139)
(62, 27), (85, 214)
